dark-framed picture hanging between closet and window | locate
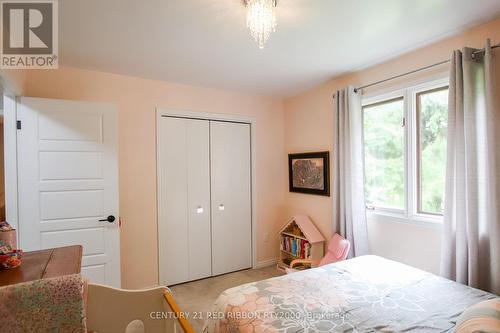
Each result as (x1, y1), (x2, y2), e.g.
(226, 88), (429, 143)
(288, 151), (330, 196)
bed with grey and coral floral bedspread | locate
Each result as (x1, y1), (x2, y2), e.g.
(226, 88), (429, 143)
(203, 256), (497, 333)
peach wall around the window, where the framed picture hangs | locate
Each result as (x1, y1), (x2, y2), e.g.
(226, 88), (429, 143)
(285, 20), (500, 272)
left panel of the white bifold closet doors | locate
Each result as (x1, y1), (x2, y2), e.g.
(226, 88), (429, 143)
(158, 117), (211, 285)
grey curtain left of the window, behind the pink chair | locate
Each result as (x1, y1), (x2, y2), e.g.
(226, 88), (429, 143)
(333, 87), (369, 257)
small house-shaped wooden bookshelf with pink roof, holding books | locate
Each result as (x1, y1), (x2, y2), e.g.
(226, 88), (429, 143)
(277, 215), (325, 270)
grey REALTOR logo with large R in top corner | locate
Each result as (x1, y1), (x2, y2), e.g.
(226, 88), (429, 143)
(0, 0), (58, 69)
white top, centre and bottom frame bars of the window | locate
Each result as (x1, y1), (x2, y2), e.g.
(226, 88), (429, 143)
(362, 77), (449, 225)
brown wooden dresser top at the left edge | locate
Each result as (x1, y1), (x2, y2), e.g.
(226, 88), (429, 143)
(0, 245), (82, 286)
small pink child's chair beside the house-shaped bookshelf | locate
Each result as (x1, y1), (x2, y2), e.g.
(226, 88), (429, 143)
(286, 234), (351, 273)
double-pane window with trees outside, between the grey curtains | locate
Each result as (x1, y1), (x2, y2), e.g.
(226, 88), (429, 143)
(363, 80), (448, 220)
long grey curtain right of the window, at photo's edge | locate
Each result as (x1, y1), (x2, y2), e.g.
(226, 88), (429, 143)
(441, 41), (500, 294)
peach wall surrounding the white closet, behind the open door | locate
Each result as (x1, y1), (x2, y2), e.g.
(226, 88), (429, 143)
(8, 68), (286, 288)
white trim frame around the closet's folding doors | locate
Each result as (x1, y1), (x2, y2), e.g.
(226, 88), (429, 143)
(156, 106), (257, 283)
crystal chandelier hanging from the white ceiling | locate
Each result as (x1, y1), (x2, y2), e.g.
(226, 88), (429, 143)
(245, 0), (277, 49)
